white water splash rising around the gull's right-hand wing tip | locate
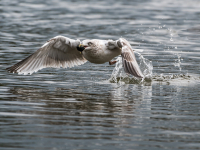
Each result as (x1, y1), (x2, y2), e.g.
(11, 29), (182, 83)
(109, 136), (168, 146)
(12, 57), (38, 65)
(109, 51), (153, 84)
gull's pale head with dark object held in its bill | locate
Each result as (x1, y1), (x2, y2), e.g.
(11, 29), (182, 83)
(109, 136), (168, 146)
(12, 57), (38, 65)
(77, 40), (96, 52)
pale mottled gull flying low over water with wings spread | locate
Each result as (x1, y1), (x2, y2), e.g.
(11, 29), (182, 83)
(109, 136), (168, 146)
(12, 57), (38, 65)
(6, 36), (144, 78)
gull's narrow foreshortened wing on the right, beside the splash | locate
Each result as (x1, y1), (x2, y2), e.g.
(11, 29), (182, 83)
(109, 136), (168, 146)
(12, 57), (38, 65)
(119, 38), (144, 78)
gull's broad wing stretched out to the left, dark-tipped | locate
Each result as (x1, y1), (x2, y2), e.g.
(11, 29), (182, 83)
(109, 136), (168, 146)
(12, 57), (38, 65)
(6, 36), (87, 74)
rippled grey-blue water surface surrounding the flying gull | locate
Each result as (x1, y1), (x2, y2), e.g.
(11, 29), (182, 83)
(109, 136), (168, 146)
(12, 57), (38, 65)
(0, 0), (200, 150)
